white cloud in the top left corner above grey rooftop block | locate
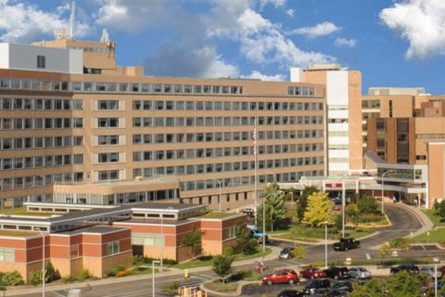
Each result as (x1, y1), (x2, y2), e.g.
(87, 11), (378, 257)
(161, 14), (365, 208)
(0, 0), (89, 43)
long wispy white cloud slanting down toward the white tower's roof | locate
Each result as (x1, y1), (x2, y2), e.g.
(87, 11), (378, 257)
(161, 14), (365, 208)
(206, 0), (335, 70)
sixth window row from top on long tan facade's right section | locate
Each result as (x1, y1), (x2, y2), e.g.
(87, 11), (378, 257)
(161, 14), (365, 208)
(133, 157), (324, 177)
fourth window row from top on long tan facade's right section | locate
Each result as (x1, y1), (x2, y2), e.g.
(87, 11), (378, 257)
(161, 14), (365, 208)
(132, 130), (323, 144)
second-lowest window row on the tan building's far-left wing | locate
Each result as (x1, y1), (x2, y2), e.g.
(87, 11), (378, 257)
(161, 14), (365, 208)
(0, 154), (84, 170)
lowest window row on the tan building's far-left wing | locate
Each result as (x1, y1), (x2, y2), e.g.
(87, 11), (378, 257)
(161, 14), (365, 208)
(0, 172), (84, 190)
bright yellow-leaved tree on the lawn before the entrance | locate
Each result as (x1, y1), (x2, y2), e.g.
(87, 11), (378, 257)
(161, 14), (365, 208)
(303, 192), (335, 227)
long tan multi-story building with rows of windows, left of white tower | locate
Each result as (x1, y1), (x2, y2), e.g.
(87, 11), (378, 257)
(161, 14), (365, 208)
(0, 39), (326, 209)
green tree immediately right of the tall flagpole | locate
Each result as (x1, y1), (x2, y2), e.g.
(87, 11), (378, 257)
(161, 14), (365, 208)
(257, 183), (286, 231)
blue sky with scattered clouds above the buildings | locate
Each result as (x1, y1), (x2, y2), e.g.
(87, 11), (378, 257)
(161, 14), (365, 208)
(0, 0), (445, 95)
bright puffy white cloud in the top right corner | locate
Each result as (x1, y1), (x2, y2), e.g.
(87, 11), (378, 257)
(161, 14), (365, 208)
(379, 0), (445, 59)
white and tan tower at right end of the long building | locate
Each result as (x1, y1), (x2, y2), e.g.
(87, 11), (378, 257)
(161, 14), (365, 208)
(291, 64), (363, 177)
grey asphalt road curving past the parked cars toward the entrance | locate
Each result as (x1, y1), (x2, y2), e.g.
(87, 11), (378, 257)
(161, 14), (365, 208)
(7, 204), (436, 297)
